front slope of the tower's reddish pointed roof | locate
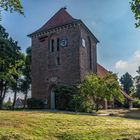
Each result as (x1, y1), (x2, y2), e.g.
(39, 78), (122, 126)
(32, 8), (77, 34)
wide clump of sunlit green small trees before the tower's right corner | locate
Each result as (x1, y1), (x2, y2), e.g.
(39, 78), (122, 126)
(79, 74), (123, 111)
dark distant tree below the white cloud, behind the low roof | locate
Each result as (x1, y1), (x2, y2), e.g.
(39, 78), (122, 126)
(120, 72), (133, 95)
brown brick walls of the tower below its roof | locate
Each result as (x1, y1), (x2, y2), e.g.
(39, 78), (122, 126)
(32, 24), (97, 108)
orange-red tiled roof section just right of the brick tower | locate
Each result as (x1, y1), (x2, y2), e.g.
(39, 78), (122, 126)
(97, 64), (108, 78)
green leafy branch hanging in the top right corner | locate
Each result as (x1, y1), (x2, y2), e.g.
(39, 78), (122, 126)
(130, 0), (140, 27)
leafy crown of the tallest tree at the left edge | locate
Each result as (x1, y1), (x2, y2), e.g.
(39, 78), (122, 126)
(0, 26), (23, 82)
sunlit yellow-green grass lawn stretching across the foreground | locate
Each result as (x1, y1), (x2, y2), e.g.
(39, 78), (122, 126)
(0, 111), (140, 140)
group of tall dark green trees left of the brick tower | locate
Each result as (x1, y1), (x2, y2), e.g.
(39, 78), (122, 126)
(0, 25), (31, 108)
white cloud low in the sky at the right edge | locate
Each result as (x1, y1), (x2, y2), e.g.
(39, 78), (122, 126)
(115, 51), (140, 76)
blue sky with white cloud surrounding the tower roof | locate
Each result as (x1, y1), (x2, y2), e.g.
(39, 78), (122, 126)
(1, 0), (140, 77)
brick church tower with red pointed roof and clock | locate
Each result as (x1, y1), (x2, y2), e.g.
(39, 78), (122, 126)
(28, 8), (102, 109)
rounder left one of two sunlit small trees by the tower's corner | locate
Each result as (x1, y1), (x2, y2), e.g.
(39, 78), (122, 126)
(79, 75), (106, 110)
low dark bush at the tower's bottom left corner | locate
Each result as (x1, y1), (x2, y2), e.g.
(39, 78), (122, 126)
(27, 98), (44, 109)
